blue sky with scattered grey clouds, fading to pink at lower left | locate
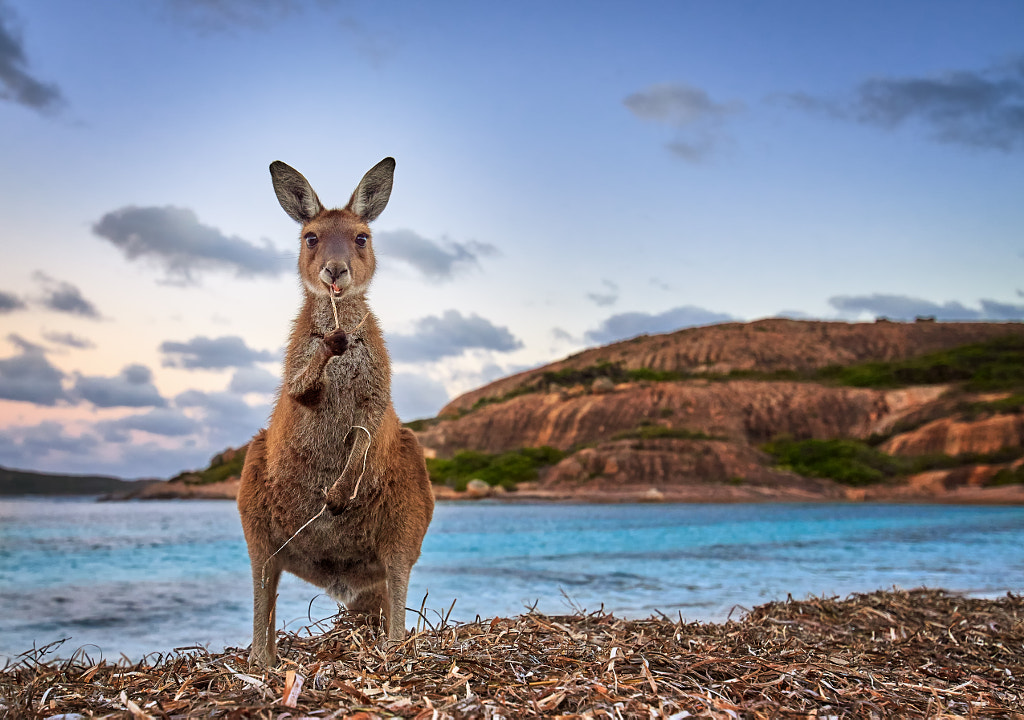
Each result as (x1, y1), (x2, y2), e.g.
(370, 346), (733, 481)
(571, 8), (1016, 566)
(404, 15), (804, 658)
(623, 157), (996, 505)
(0, 0), (1024, 477)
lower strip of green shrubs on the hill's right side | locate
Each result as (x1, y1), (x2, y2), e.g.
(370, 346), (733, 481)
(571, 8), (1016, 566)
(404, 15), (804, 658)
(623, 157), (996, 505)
(761, 438), (1024, 485)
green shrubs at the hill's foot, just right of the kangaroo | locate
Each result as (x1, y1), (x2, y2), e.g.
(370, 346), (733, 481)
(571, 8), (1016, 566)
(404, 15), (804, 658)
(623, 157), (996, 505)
(427, 446), (564, 491)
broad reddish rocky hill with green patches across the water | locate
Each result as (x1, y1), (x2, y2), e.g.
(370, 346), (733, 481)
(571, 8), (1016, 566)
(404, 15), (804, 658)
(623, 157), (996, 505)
(413, 319), (1024, 502)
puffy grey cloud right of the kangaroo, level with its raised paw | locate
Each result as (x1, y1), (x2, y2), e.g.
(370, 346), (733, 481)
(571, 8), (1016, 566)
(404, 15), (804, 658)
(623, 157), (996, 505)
(387, 310), (522, 363)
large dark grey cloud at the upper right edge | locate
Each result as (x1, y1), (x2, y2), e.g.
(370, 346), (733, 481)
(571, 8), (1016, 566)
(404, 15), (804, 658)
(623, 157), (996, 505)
(784, 57), (1024, 153)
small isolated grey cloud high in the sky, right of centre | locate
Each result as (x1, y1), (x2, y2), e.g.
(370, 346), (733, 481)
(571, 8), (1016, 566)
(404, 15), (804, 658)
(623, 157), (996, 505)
(623, 83), (743, 163)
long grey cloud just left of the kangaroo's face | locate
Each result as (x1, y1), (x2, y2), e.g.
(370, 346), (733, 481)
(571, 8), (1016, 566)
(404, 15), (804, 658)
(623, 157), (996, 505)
(92, 206), (286, 285)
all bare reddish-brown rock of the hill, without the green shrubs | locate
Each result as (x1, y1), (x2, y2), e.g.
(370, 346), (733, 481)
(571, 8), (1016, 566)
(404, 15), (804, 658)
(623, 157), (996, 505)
(418, 320), (1024, 501)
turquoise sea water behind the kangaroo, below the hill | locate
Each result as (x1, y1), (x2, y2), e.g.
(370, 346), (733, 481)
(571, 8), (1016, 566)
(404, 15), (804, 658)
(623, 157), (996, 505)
(0, 498), (1024, 660)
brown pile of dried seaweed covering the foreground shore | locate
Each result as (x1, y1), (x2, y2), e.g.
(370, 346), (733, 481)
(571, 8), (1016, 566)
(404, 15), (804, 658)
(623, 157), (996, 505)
(0, 590), (1024, 720)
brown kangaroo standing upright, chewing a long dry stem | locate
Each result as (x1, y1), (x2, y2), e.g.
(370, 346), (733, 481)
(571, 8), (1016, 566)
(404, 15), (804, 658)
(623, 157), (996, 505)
(239, 158), (434, 666)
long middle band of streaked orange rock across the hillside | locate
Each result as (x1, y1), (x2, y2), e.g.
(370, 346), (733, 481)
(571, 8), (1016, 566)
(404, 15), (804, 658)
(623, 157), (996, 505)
(419, 380), (944, 457)
